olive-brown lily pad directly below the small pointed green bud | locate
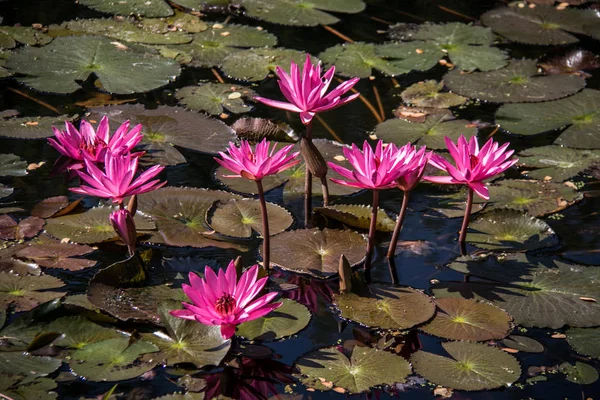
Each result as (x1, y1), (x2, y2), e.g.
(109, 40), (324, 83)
(333, 284), (435, 330)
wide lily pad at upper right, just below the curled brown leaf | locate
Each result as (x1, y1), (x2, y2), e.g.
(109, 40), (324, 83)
(444, 59), (585, 104)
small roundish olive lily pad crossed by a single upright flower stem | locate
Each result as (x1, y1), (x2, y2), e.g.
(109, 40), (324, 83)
(208, 199), (294, 238)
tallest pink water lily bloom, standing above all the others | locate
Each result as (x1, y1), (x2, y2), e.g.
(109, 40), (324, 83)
(255, 54), (360, 125)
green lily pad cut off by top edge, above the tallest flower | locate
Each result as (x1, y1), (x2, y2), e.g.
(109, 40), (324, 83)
(238, 0), (365, 26)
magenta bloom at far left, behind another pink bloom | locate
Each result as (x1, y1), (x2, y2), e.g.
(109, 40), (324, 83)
(48, 116), (143, 169)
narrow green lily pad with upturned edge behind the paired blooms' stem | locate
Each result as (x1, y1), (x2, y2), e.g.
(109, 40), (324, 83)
(314, 204), (396, 232)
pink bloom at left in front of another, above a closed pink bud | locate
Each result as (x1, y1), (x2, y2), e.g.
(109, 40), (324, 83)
(71, 151), (167, 204)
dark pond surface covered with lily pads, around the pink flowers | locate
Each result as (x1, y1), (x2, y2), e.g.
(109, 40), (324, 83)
(0, 0), (600, 400)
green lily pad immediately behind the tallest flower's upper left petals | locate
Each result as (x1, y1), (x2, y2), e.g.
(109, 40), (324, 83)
(221, 48), (318, 81)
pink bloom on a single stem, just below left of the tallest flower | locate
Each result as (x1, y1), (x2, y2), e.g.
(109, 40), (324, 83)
(215, 139), (300, 181)
